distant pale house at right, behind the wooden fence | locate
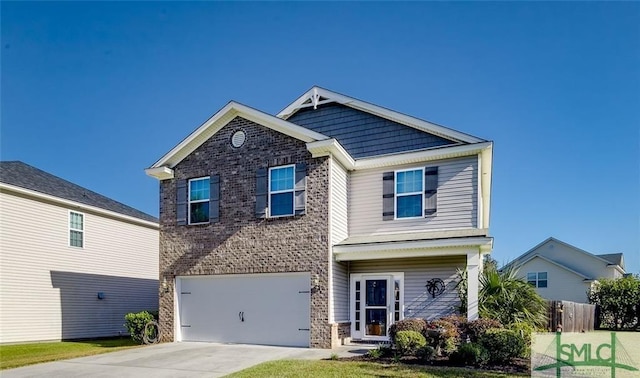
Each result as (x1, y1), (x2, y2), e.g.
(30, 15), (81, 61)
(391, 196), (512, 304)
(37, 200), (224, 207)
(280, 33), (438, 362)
(502, 237), (625, 303)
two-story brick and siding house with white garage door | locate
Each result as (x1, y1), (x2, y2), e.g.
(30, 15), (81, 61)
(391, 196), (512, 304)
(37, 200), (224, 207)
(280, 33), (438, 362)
(146, 87), (493, 348)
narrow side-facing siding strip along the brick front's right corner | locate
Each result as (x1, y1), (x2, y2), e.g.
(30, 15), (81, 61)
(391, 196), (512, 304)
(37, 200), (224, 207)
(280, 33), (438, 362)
(329, 160), (349, 322)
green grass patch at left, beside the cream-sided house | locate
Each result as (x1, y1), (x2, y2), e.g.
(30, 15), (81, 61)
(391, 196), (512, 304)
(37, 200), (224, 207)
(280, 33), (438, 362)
(0, 338), (140, 369)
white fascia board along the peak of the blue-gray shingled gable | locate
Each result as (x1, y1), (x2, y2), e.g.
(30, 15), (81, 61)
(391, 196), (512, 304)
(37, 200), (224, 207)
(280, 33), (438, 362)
(277, 87), (485, 143)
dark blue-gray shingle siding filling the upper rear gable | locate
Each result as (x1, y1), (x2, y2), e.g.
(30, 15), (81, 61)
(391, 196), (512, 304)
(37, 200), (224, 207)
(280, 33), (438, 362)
(287, 103), (455, 159)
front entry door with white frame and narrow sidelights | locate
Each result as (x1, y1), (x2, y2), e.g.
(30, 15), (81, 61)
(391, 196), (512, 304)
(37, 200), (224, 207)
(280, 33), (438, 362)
(351, 274), (402, 340)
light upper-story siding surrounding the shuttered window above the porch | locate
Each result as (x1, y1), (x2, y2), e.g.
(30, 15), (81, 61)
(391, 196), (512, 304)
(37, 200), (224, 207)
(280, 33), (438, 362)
(349, 156), (478, 236)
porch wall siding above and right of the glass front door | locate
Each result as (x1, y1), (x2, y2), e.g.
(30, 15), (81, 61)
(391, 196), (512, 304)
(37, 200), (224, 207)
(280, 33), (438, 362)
(350, 256), (466, 320)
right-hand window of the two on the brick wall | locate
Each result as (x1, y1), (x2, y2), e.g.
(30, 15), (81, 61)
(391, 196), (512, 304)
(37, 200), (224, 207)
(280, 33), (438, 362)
(269, 165), (295, 217)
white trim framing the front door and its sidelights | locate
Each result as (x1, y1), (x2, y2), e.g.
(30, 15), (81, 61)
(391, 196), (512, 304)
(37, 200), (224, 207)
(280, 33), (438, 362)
(349, 272), (405, 341)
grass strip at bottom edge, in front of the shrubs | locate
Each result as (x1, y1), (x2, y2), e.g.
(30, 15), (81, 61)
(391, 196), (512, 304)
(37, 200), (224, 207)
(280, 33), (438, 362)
(228, 360), (528, 378)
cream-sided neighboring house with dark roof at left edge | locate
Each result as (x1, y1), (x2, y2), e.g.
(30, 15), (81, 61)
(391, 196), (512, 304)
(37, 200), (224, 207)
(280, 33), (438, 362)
(0, 161), (158, 343)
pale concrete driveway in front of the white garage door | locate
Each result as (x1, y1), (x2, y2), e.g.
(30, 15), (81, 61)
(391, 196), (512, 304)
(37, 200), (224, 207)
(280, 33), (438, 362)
(0, 342), (373, 378)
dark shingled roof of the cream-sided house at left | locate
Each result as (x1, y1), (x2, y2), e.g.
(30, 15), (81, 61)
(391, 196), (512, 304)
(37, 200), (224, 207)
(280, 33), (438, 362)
(0, 161), (158, 223)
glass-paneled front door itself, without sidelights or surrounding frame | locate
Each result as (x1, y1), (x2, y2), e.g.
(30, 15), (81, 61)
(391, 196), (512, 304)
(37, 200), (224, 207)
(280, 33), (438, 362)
(364, 278), (392, 337)
